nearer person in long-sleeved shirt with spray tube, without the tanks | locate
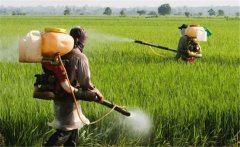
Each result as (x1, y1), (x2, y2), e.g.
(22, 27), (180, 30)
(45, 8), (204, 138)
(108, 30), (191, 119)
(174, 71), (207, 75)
(42, 26), (130, 146)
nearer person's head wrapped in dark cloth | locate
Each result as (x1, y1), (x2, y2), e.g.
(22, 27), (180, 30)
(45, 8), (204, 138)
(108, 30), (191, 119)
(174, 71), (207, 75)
(70, 26), (87, 52)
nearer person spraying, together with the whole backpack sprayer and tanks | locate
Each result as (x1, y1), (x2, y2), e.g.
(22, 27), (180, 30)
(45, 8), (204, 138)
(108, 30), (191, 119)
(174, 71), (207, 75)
(19, 26), (130, 146)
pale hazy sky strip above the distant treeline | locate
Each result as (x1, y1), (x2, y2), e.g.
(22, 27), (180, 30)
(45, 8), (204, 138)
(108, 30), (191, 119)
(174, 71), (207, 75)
(0, 0), (239, 8)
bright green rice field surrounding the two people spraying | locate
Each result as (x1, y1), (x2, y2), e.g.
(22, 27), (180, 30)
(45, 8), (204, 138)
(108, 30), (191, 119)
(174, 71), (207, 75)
(0, 16), (240, 146)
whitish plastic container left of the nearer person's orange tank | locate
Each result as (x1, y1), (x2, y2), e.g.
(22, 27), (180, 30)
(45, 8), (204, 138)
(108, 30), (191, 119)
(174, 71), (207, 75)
(19, 30), (42, 63)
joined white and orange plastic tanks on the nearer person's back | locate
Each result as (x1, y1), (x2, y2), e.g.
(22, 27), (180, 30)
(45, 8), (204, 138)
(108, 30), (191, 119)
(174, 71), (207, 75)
(19, 28), (74, 63)
